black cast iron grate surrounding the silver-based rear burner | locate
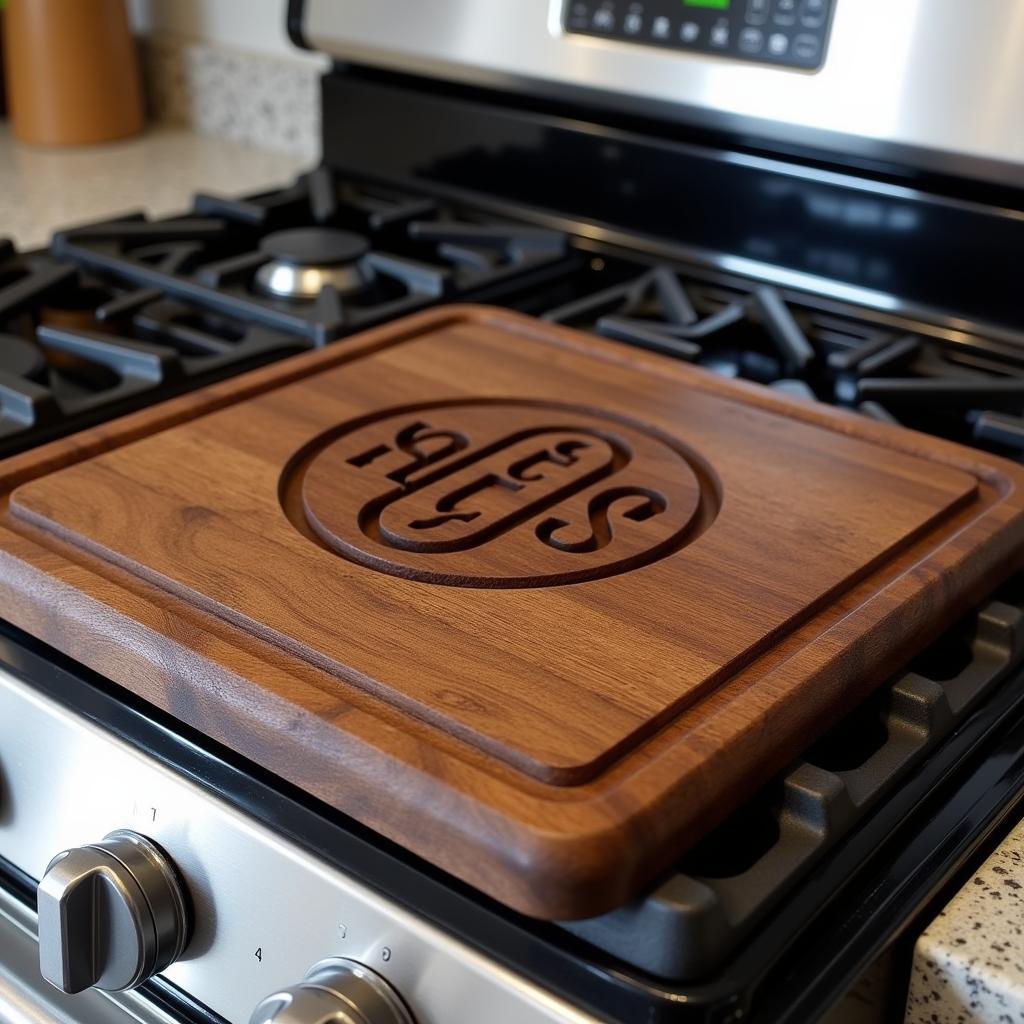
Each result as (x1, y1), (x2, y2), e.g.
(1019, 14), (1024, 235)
(52, 167), (571, 344)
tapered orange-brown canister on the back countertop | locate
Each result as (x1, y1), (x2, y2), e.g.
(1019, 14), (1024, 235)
(4, 0), (142, 145)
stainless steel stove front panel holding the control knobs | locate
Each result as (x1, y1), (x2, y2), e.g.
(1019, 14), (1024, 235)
(0, 663), (598, 1024)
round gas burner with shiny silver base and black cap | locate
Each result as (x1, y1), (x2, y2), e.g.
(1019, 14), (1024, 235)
(255, 225), (377, 299)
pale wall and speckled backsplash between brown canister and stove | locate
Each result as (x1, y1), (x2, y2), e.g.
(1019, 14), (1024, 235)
(128, 0), (328, 158)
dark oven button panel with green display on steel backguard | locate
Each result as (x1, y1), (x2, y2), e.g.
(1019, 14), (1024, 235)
(562, 0), (836, 71)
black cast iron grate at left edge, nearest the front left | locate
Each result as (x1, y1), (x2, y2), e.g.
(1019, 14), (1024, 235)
(0, 241), (308, 456)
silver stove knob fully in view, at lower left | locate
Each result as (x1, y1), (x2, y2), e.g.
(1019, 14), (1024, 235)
(37, 830), (190, 992)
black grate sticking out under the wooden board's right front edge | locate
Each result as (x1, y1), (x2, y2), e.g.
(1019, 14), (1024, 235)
(562, 577), (1024, 982)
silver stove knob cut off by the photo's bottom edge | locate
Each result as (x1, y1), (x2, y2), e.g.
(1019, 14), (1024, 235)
(249, 959), (415, 1024)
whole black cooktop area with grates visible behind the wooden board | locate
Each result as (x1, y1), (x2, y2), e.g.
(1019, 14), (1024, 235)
(6, 167), (1024, 468)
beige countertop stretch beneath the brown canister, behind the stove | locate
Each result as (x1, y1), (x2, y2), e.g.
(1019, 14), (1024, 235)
(0, 121), (313, 249)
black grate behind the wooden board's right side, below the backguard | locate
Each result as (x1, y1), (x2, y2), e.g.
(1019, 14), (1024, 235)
(543, 264), (1024, 461)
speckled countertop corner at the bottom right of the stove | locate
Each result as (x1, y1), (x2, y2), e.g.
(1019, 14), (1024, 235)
(906, 822), (1024, 1024)
